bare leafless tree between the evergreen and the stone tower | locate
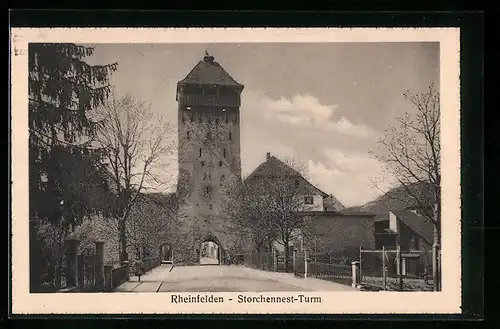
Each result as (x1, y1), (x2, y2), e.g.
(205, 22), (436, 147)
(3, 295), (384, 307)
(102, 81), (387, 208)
(97, 94), (175, 261)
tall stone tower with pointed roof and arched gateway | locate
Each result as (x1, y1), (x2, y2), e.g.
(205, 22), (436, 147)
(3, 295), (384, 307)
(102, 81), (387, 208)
(176, 53), (244, 261)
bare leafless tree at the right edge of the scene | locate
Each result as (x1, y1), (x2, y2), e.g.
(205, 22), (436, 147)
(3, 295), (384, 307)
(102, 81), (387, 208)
(372, 85), (441, 290)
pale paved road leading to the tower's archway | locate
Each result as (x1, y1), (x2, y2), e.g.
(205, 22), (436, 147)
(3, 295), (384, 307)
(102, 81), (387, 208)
(115, 264), (359, 292)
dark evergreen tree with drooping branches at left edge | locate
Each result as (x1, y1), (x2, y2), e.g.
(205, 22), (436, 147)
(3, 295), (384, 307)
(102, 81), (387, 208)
(29, 43), (117, 291)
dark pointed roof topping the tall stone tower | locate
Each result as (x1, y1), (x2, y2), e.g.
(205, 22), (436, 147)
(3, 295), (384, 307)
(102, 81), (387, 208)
(179, 56), (243, 88)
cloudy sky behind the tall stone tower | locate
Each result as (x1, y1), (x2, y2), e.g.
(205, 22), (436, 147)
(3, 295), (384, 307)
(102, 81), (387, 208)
(88, 42), (439, 206)
